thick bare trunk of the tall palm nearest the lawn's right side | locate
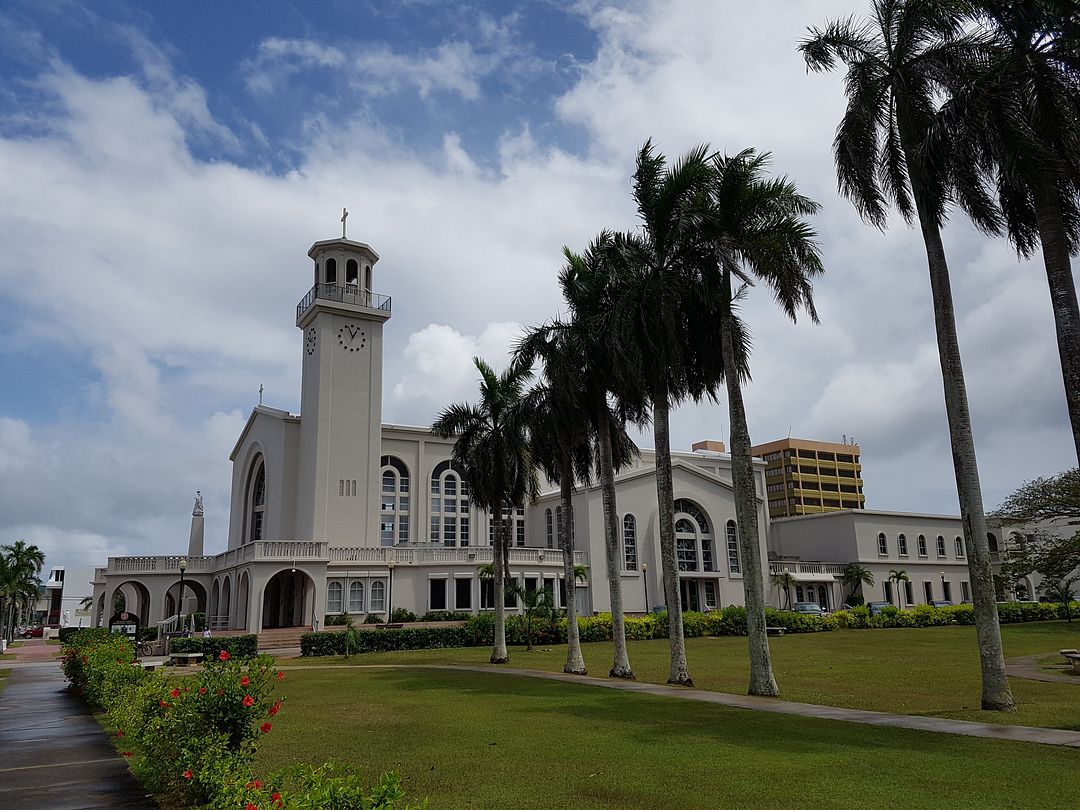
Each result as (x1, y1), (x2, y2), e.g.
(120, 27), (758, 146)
(904, 149), (1015, 712)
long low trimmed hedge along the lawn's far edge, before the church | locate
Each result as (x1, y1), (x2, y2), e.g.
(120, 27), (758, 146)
(300, 603), (1080, 656)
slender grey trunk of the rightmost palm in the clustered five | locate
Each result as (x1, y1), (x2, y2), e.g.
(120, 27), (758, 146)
(720, 304), (780, 697)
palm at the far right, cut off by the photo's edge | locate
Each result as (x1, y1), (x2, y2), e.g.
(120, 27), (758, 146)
(940, 0), (1080, 459)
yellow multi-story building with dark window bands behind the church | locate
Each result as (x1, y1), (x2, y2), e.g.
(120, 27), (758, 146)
(751, 438), (866, 519)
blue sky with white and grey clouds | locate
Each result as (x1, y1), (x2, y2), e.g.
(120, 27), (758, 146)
(0, 0), (1075, 583)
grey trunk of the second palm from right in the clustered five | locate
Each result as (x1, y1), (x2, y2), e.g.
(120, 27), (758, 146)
(652, 384), (693, 686)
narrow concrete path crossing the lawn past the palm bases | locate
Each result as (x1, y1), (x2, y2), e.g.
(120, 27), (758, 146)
(278, 664), (1080, 748)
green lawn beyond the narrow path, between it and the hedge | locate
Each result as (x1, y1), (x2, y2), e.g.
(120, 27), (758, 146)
(282, 622), (1080, 729)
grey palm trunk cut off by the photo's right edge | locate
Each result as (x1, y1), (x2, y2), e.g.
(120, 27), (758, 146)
(1035, 180), (1080, 461)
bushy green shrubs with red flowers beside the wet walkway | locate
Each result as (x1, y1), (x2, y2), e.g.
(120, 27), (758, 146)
(64, 631), (427, 810)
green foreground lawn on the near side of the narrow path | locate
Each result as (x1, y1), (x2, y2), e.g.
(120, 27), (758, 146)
(259, 665), (1080, 810)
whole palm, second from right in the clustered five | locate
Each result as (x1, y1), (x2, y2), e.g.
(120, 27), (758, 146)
(611, 141), (719, 686)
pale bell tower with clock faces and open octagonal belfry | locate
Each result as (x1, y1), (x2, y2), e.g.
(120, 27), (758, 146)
(295, 234), (390, 546)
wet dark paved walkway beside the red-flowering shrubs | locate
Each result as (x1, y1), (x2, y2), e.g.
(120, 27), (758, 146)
(0, 660), (157, 810)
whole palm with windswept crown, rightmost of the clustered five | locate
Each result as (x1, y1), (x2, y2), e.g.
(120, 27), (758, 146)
(700, 149), (824, 696)
